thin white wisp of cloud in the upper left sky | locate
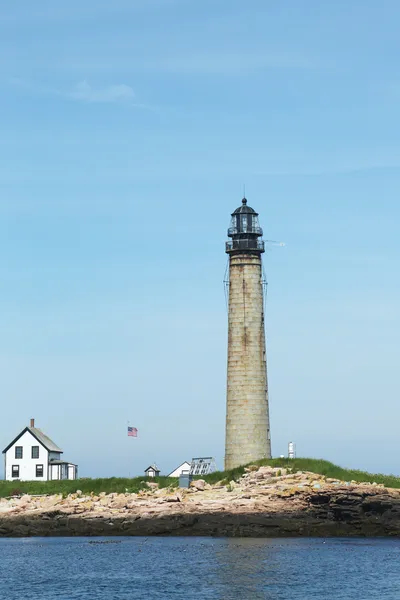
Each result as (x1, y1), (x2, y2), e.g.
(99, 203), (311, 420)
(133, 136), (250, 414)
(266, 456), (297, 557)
(9, 79), (144, 107)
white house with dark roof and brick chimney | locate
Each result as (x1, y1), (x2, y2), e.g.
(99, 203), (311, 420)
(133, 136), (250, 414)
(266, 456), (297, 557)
(3, 419), (78, 481)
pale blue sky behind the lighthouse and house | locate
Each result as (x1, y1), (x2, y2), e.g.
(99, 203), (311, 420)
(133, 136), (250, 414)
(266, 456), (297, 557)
(0, 0), (400, 476)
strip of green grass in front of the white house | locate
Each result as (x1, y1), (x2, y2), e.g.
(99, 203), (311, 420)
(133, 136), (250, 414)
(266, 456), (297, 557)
(0, 477), (178, 498)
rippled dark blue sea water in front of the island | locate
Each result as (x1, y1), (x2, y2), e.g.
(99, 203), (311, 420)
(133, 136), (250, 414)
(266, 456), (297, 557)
(0, 537), (400, 600)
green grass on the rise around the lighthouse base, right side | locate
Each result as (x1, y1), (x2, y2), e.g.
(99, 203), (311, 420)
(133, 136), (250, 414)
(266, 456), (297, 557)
(204, 458), (400, 488)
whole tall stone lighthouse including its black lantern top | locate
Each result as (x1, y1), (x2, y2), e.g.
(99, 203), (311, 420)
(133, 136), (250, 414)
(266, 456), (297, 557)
(225, 198), (271, 469)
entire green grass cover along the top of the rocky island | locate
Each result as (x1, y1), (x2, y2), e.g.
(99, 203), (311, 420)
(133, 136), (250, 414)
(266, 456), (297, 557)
(0, 458), (400, 498)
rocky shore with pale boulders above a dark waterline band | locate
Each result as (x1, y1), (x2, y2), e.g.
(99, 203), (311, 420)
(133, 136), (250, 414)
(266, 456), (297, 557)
(0, 467), (400, 537)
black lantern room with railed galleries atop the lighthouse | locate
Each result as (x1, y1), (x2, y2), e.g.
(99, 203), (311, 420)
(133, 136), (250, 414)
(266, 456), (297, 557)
(226, 198), (264, 254)
